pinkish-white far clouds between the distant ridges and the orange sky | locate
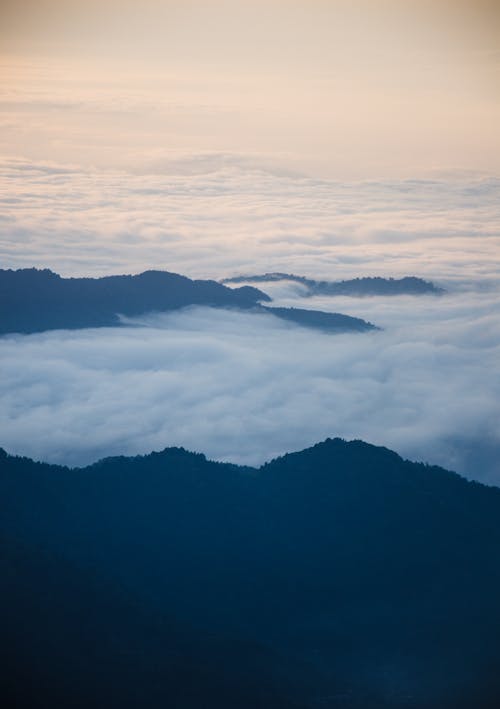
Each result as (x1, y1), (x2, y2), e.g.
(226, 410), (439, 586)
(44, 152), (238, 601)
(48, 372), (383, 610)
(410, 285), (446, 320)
(0, 153), (500, 285)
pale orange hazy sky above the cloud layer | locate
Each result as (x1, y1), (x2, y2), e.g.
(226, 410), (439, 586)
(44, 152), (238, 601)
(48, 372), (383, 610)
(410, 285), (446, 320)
(0, 0), (500, 179)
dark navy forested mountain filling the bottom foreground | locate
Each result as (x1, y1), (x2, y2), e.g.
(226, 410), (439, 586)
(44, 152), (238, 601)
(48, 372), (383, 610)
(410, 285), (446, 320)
(0, 439), (500, 709)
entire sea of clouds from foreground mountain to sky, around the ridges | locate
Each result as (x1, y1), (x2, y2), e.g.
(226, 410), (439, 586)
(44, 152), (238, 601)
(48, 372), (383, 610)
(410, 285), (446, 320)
(0, 154), (500, 484)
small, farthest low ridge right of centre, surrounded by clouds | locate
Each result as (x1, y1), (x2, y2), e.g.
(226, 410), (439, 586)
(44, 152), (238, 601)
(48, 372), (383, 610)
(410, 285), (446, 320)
(221, 273), (444, 296)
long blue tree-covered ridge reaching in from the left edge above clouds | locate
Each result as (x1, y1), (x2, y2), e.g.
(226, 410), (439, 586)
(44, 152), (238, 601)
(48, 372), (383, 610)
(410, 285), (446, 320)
(0, 268), (376, 334)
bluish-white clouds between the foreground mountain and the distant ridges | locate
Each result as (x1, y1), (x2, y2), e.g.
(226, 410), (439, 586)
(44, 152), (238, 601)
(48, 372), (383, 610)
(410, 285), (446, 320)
(0, 280), (500, 484)
